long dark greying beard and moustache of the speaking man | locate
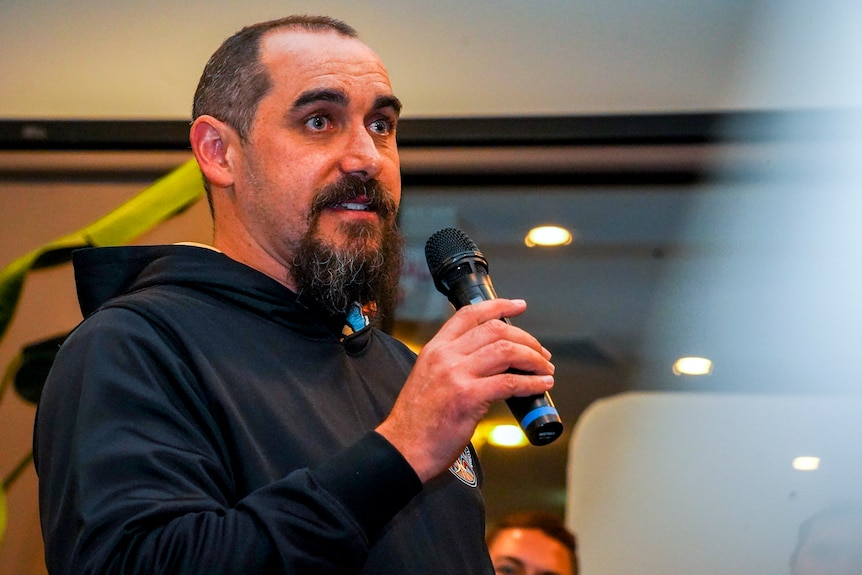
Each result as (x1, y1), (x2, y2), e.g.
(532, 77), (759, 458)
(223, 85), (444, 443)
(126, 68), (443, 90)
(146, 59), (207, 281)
(292, 176), (404, 316)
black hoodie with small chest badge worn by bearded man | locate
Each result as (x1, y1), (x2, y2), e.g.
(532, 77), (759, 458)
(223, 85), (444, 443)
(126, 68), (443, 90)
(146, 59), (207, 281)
(34, 246), (493, 575)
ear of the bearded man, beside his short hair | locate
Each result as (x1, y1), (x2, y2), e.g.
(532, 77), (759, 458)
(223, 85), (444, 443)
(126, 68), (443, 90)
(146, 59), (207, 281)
(189, 116), (239, 188)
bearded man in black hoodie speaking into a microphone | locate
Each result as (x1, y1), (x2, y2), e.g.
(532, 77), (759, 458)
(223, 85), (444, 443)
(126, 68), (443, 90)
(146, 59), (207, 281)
(34, 13), (553, 575)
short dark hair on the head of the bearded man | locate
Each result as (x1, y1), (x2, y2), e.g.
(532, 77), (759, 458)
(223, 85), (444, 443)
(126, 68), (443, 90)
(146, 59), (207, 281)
(192, 15), (358, 140)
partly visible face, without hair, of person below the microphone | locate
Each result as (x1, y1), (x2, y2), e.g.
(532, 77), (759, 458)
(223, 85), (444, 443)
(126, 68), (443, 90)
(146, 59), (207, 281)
(488, 528), (574, 575)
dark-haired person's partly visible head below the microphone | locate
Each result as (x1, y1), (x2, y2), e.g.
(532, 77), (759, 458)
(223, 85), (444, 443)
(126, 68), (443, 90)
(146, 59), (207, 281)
(487, 511), (578, 575)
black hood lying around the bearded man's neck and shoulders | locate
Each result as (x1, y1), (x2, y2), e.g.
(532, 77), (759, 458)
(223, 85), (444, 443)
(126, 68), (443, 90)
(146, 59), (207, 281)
(72, 245), (344, 337)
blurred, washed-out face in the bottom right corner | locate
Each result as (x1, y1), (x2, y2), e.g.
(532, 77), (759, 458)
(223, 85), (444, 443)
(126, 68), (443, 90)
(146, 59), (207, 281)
(791, 517), (862, 575)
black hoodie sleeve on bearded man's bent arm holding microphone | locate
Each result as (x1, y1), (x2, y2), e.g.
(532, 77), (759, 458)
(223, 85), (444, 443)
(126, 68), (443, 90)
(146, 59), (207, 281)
(34, 310), (422, 575)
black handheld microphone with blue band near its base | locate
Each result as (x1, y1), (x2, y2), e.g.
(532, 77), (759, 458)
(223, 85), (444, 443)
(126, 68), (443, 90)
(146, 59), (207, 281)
(425, 228), (563, 445)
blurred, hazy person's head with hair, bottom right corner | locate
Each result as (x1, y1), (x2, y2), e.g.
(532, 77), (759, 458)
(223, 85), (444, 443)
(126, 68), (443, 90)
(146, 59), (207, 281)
(790, 503), (862, 575)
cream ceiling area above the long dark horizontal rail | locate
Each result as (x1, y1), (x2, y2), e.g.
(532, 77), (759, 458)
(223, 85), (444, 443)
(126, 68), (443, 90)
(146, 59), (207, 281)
(0, 0), (852, 119)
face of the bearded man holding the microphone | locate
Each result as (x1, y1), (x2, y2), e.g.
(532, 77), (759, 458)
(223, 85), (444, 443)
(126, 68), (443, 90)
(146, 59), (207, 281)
(231, 30), (401, 296)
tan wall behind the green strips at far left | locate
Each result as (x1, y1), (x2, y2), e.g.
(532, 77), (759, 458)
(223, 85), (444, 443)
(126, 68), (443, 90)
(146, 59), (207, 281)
(0, 154), (210, 575)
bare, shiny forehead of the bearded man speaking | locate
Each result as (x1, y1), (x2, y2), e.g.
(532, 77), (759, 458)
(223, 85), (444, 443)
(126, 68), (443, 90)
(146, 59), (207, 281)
(261, 29), (392, 99)
